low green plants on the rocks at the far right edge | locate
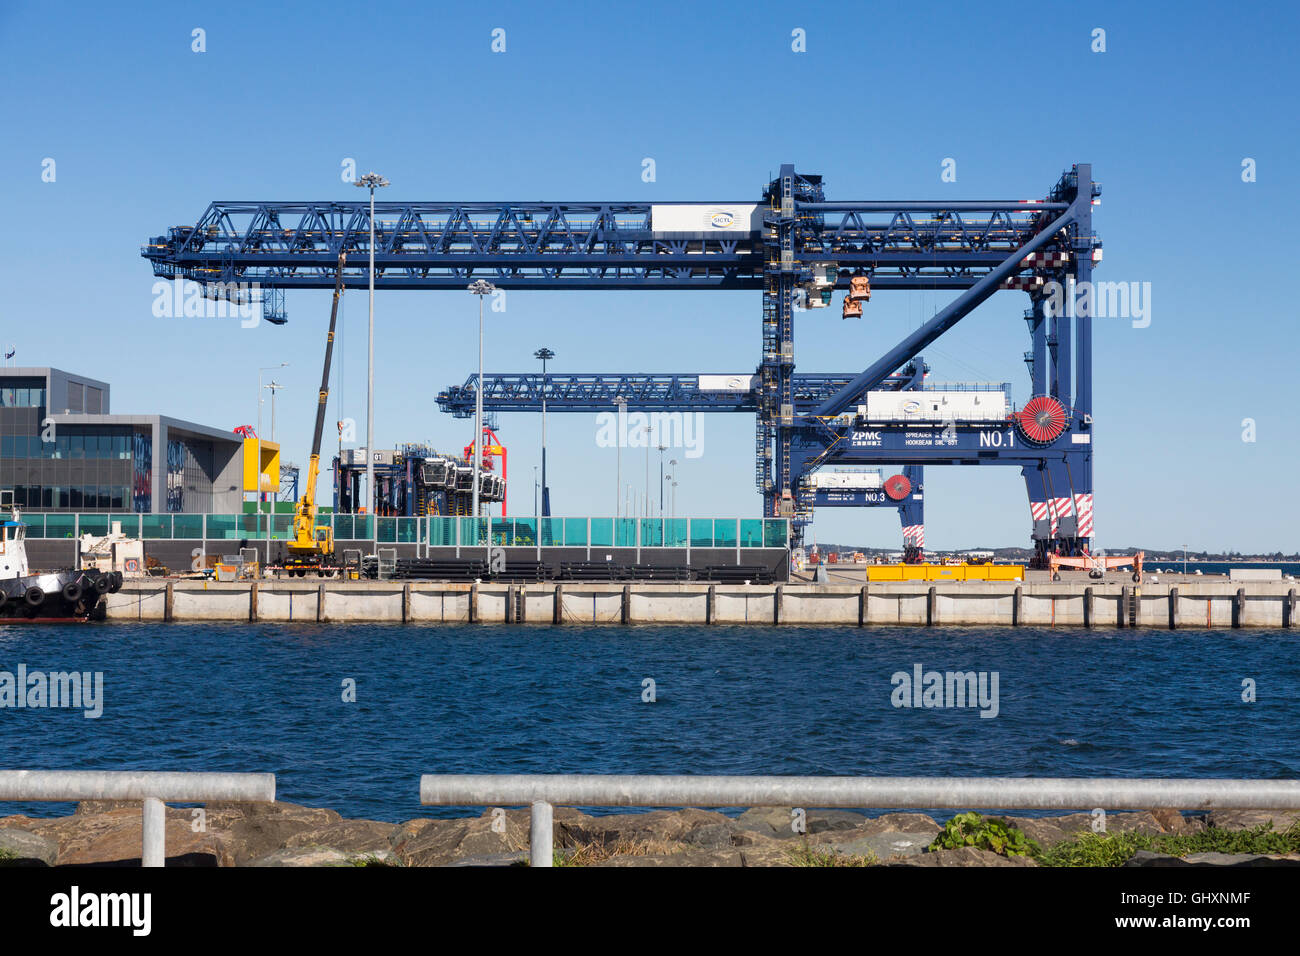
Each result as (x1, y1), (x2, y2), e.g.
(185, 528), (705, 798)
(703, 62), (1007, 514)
(1036, 821), (1300, 866)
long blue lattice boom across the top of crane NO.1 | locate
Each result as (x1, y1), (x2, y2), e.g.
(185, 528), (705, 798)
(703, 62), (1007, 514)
(140, 202), (1049, 291)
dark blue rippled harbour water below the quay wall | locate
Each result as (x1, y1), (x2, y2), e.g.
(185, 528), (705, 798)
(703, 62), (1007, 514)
(0, 623), (1300, 821)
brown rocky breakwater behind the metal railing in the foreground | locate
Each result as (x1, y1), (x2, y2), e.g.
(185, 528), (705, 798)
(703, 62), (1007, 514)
(0, 803), (1300, 866)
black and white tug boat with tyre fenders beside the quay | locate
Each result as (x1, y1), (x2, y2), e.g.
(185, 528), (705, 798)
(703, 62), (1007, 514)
(0, 509), (122, 624)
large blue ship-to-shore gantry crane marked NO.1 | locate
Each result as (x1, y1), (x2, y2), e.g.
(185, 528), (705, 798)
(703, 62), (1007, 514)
(142, 164), (1101, 563)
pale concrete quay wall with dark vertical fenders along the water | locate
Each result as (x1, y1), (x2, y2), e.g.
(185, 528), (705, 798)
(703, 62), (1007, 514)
(107, 579), (1296, 628)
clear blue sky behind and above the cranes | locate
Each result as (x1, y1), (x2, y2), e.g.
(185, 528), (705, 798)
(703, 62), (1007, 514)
(0, 3), (1300, 550)
